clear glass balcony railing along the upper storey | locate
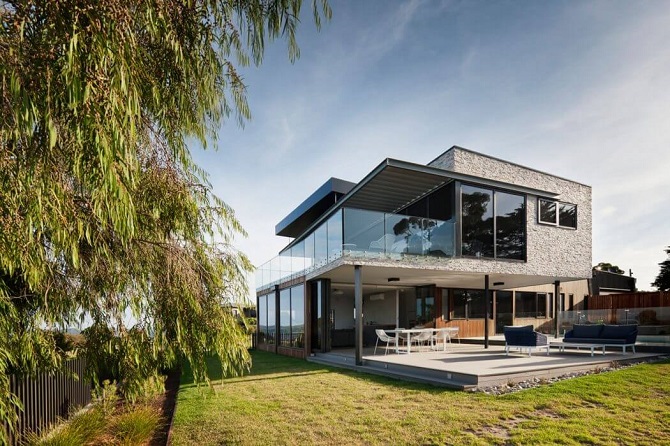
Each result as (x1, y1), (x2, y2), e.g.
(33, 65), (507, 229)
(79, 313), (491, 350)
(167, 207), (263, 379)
(256, 208), (455, 289)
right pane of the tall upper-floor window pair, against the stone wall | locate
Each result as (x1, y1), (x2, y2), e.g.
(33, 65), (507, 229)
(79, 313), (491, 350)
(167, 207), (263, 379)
(495, 191), (526, 260)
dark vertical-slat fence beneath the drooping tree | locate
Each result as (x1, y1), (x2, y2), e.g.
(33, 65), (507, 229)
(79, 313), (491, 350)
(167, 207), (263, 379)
(2, 359), (91, 445)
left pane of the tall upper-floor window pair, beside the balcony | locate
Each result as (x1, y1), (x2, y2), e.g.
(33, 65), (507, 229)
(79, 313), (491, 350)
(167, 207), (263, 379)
(461, 185), (494, 257)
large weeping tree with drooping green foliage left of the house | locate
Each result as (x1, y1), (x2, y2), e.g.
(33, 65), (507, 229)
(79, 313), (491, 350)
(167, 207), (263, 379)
(0, 0), (331, 435)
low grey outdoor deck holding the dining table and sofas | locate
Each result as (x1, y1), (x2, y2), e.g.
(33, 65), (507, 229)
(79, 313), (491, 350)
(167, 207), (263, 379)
(309, 343), (659, 390)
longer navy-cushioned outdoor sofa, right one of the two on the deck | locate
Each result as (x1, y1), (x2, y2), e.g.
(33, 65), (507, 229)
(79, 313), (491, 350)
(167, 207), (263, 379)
(563, 324), (637, 353)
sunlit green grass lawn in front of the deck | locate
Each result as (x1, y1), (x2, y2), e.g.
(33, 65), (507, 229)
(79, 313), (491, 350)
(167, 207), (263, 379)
(172, 351), (670, 445)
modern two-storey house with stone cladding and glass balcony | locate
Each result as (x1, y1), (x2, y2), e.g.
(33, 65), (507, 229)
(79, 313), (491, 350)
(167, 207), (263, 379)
(256, 147), (591, 363)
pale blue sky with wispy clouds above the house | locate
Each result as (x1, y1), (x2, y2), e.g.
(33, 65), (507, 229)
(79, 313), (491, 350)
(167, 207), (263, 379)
(192, 0), (670, 295)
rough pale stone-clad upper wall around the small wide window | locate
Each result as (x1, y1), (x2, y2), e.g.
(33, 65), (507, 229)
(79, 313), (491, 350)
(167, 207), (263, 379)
(429, 147), (592, 278)
